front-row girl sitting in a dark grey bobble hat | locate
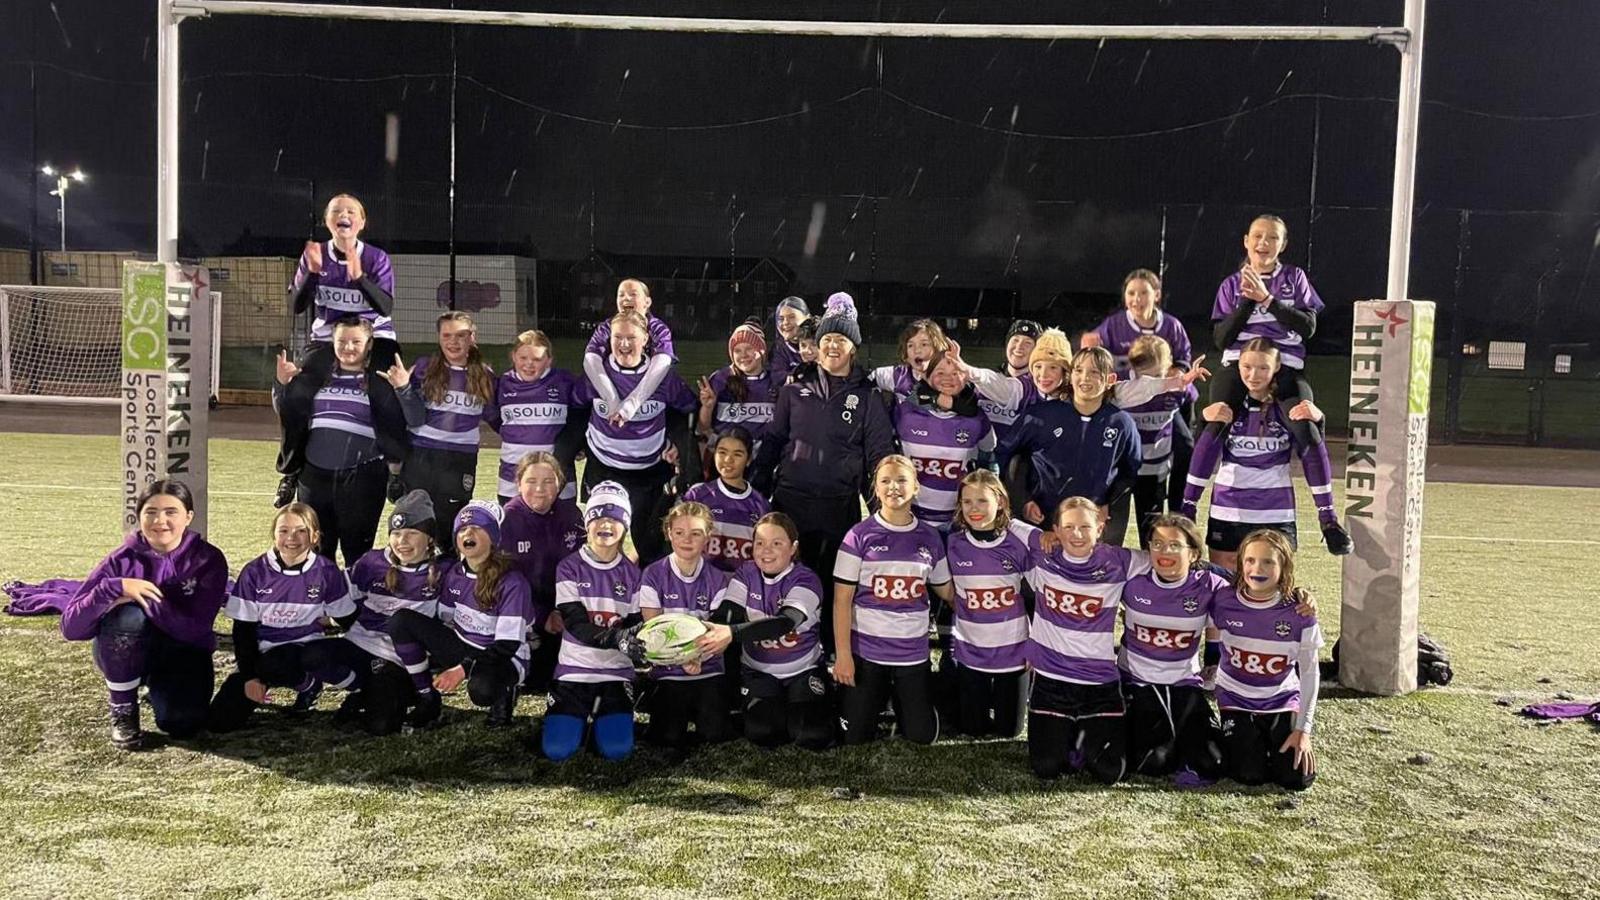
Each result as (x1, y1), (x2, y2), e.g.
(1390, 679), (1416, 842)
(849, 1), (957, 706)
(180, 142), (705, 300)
(315, 490), (445, 735)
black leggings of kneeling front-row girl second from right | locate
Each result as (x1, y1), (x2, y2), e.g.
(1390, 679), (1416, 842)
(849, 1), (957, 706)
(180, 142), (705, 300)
(1126, 684), (1222, 780)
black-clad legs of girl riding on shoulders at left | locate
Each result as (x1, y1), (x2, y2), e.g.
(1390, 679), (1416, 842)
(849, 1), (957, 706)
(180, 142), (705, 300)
(278, 338), (406, 476)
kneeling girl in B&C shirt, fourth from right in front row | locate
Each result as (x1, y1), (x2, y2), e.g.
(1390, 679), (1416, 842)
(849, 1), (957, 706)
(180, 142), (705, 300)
(939, 469), (1038, 738)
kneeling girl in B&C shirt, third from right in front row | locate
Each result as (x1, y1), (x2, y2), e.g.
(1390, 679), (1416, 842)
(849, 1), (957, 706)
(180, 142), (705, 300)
(1027, 493), (1150, 785)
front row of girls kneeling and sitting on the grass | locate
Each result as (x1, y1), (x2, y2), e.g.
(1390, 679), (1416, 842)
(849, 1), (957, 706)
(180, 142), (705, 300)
(62, 464), (1322, 790)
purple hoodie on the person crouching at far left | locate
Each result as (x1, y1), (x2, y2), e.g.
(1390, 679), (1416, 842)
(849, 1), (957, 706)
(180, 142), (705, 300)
(61, 532), (227, 650)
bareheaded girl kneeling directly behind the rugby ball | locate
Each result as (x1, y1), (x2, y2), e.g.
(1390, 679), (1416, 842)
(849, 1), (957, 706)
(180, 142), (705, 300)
(638, 503), (733, 749)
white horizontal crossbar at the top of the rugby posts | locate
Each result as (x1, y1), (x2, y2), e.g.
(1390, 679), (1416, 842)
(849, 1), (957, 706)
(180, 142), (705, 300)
(173, 0), (1408, 45)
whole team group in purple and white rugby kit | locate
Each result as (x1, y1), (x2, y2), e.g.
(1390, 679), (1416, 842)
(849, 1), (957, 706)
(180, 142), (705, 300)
(56, 206), (1349, 783)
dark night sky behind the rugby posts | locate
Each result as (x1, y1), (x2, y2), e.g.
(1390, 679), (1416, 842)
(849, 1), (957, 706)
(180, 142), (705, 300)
(0, 0), (1600, 338)
